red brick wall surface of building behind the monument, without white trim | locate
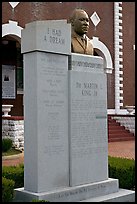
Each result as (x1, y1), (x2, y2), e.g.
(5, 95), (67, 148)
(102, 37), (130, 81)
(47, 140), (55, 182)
(2, 2), (135, 115)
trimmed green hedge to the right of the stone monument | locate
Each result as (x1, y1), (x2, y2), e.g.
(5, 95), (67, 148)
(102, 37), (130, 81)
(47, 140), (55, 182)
(108, 156), (135, 189)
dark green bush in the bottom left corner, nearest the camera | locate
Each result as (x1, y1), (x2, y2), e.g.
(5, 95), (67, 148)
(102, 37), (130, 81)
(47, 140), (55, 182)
(2, 177), (15, 202)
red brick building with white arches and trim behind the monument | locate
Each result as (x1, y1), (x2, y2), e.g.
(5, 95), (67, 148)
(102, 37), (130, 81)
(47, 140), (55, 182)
(2, 2), (135, 116)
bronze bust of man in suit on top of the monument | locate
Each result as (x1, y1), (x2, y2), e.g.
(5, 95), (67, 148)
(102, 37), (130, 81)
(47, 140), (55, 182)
(69, 9), (94, 55)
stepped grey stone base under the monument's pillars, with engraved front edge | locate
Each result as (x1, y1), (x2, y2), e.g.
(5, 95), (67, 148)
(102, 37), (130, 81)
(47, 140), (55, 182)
(14, 178), (135, 202)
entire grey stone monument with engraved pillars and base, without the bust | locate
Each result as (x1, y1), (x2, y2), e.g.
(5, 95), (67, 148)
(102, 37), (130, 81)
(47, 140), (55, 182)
(15, 20), (135, 202)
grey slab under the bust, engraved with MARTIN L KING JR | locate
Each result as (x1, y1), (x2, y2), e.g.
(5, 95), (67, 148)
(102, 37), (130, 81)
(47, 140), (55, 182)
(69, 56), (108, 186)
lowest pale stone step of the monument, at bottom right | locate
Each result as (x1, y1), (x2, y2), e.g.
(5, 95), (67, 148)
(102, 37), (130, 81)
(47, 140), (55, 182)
(79, 189), (135, 202)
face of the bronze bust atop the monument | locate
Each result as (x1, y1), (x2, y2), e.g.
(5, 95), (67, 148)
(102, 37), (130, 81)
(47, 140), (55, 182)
(72, 11), (89, 36)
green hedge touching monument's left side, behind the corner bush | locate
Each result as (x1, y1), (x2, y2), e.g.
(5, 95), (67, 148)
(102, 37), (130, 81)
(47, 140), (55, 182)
(2, 164), (24, 188)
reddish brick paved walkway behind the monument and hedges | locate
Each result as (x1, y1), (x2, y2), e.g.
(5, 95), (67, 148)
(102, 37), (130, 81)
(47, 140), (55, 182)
(2, 141), (135, 166)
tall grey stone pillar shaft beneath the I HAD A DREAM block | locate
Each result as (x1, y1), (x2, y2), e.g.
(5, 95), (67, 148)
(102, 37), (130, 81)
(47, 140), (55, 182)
(24, 52), (69, 192)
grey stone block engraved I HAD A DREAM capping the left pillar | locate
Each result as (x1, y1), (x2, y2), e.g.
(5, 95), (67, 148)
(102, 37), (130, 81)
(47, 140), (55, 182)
(21, 20), (71, 54)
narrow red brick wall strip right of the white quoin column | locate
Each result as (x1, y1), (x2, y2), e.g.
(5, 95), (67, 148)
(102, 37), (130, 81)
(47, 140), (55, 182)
(123, 2), (135, 105)
